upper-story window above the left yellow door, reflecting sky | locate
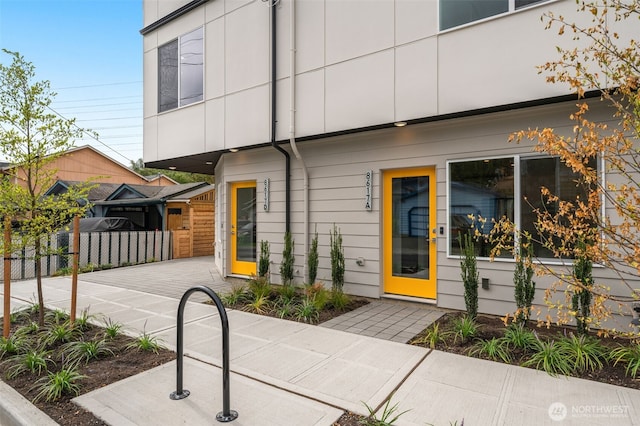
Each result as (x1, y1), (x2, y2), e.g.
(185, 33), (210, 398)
(158, 27), (204, 112)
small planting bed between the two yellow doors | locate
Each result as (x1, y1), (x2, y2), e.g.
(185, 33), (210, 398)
(221, 277), (369, 324)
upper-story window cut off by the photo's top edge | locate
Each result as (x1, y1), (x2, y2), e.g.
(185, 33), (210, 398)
(440, 0), (547, 30)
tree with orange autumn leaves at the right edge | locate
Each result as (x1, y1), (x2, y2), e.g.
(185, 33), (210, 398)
(496, 0), (640, 330)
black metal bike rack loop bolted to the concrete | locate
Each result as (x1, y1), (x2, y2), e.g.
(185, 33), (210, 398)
(169, 286), (238, 422)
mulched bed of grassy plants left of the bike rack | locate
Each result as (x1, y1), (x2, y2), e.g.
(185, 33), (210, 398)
(0, 308), (175, 426)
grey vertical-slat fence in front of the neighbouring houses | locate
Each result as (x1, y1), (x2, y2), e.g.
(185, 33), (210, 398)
(0, 231), (172, 280)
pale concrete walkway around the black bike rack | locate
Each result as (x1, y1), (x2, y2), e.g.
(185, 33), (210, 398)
(0, 261), (640, 426)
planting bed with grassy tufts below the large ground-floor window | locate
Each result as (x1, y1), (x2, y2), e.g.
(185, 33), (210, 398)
(410, 312), (640, 389)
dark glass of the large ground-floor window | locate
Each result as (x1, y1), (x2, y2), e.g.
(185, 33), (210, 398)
(448, 156), (597, 258)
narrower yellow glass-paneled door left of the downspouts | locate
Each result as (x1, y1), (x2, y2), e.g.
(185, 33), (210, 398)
(230, 182), (257, 275)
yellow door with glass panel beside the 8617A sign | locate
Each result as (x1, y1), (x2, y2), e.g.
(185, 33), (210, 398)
(382, 167), (436, 299)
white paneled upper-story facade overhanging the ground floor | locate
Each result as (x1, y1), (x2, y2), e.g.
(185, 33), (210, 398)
(143, 0), (592, 162)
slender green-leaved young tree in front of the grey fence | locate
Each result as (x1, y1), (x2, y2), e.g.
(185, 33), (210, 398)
(0, 49), (90, 325)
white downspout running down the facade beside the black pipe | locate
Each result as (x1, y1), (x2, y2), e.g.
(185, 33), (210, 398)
(289, 0), (313, 284)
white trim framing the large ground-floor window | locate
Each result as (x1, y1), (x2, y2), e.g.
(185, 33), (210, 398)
(445, 152), (607, 267)
